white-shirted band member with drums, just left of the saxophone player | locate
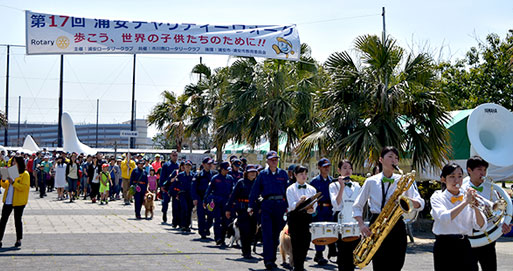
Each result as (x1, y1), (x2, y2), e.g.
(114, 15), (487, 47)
(329, 159), (361, 271)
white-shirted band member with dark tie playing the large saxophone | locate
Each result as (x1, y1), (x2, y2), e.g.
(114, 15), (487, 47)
(353, 146), (424, 271)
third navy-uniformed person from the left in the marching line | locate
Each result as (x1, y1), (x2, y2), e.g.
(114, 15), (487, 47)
(177, 160), (196, 232)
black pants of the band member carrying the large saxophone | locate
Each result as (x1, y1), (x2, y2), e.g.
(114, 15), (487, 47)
(371, 215), (407, 271)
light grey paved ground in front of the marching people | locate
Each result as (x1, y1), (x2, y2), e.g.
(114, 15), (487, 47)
(0, 191), (513, 270)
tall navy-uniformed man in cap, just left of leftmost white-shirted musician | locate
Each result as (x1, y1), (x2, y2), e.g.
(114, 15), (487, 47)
(248, 151), (289, 270)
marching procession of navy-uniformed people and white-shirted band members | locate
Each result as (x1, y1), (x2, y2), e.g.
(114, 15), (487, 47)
(122, 147), (511, 270)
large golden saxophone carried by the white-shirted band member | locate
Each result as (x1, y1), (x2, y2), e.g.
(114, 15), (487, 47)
(353, 166), (415, 269)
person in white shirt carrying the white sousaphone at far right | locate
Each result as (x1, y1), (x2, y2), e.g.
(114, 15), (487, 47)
(462, 156), (512, 271)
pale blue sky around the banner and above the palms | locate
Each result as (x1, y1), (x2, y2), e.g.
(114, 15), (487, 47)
(0, 0), (513, 138)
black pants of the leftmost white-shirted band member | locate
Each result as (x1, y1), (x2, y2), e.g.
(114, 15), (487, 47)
(287, 211), (312, 270)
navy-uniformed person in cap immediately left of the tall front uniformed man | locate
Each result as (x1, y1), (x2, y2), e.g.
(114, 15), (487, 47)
(226, 165), (258, 259)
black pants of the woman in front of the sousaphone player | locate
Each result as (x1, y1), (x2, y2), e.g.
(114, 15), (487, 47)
(433, 235), (477, 271)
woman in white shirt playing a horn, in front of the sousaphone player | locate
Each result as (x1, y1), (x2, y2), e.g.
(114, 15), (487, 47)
(431, 163), (486, 271)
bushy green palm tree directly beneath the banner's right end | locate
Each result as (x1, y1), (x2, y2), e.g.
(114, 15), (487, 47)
(219, 44), (319, 153)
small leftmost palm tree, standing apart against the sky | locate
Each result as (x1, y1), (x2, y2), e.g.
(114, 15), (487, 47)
(148, 90), (189, 152)
